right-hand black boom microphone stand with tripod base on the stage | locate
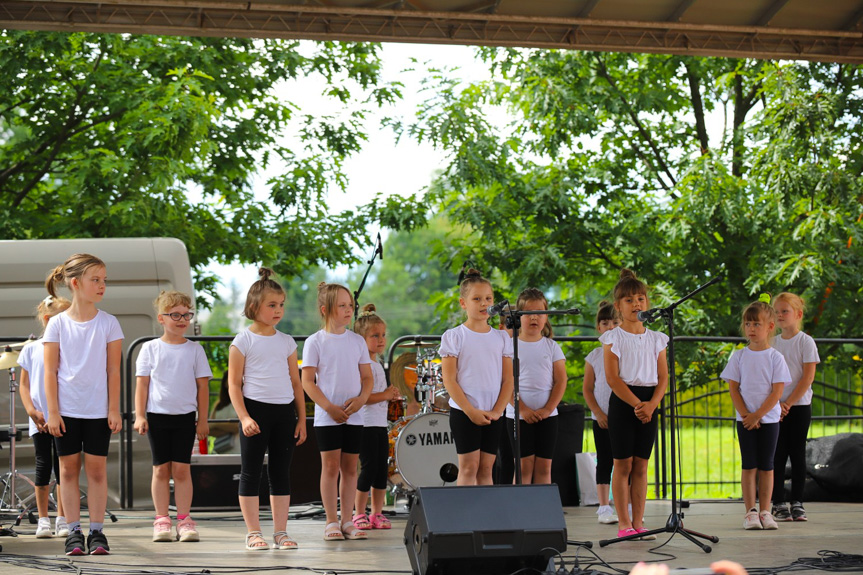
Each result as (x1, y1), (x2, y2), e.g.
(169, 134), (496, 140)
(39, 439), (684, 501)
(599, 277), (720, 553)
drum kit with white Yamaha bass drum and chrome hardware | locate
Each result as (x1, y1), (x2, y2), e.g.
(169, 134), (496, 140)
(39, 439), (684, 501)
(387, 341), (458, 495)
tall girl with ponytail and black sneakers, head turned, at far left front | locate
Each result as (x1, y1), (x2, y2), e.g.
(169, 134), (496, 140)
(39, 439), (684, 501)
(43, 254), (123, 555)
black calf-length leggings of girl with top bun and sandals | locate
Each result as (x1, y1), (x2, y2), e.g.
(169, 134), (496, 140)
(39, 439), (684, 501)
(239, 398), (297, 497)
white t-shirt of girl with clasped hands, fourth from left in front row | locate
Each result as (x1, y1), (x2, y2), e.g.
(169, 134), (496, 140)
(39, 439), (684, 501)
(303, 330), (372, 427)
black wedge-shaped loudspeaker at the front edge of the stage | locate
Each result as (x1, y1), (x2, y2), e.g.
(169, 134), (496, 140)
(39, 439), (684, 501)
(404, 485), (566, 575)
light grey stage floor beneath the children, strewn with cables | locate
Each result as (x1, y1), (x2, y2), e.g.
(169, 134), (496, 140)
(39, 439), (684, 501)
(0, 501), (863, 575)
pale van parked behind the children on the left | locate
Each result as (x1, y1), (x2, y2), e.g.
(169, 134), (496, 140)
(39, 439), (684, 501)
(0, 238), (195, 506)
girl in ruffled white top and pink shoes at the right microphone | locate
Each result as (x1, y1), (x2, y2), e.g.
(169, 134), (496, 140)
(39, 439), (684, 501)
(599, 269), (668, 539)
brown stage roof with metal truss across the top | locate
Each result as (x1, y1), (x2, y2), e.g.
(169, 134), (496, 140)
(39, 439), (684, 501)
(0, 0), (863, 64)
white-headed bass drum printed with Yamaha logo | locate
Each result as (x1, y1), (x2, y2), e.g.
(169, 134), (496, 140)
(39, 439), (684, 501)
(389, 413), (458, 490)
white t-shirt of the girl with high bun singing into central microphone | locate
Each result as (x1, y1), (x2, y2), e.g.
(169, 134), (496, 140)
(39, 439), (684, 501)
(438, 324), (512, 411)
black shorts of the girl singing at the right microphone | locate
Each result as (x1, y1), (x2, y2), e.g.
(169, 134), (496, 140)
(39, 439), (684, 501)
(608, 385), (659, 459)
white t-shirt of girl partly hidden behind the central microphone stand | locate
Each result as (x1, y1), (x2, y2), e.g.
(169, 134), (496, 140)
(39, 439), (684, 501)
(506, 337), (566, 419)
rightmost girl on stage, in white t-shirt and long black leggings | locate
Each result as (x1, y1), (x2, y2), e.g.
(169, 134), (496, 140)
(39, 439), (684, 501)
(773, 292), (821, 521)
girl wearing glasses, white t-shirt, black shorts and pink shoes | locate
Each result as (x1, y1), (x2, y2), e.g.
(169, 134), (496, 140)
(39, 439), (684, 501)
(134, 291), (213, 541)
